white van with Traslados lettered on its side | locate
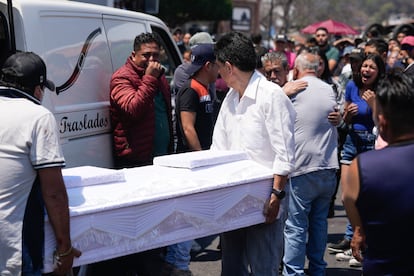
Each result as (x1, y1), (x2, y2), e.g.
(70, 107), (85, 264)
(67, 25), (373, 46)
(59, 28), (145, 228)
(0, 0), (182, 168)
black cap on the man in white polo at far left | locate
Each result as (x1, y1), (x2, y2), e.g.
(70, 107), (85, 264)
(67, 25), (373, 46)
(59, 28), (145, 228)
(1, 52), (55, 91)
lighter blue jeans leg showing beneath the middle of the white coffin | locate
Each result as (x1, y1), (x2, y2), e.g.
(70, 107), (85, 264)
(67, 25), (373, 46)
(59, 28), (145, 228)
(165, 240), (193, 270)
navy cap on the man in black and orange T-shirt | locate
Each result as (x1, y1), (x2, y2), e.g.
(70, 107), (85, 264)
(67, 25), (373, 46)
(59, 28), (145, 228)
(187, 43), (216, 76)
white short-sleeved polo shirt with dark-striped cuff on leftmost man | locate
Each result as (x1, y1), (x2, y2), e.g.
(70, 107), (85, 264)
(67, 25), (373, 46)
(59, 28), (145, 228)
(0, 96), (65, 275)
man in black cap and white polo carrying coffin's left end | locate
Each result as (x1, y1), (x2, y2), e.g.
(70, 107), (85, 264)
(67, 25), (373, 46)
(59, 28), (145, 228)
(0, 52), (81, 276)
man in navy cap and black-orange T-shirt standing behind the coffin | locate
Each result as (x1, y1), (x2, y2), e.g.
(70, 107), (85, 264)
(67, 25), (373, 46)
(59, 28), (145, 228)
(163, 44), (218, 276)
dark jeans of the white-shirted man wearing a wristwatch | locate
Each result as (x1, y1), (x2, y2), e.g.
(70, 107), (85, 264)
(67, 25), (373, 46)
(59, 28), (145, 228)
(220, 185), (289, 276)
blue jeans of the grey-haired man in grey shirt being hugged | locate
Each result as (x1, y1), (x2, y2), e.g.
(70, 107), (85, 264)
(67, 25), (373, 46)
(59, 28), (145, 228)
(283, 169), (336, 275)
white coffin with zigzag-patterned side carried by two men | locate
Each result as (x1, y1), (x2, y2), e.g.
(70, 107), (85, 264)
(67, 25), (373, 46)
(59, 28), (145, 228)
(44, 151), (273, 272)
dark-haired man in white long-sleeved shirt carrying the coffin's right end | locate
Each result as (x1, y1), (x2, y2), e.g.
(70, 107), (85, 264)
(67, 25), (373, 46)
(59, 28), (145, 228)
(211, 32), (296, 276)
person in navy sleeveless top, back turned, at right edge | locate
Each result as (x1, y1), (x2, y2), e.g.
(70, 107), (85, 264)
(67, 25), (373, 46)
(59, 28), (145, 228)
(342, 70), (414, 275)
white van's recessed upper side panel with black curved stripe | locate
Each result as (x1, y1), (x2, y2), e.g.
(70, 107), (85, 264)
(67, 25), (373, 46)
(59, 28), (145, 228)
(39, 12), (112, 108)
